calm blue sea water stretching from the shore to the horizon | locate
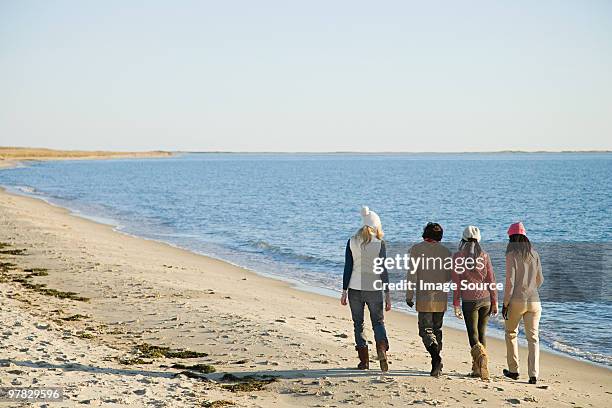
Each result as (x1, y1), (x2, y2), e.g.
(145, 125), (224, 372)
(0, 153), (612, 366)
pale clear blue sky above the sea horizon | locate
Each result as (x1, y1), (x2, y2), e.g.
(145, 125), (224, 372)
(0, 0), (612, 152)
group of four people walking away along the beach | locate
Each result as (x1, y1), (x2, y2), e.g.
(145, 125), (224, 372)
(340, 207), (544, 384)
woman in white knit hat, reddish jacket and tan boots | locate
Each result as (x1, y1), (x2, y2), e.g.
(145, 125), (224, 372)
(451, 225), (497, 380)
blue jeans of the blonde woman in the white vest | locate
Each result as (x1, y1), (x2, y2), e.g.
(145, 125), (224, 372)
(348, 289), (387, 347)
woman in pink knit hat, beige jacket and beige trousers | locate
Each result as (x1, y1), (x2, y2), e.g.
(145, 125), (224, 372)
(502, 222), (544, 384)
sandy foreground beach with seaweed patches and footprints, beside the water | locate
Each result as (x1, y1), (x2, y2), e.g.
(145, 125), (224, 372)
(0, 182), (612, 407)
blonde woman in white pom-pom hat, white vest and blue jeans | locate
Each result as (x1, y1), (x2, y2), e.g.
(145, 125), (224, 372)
(340, 206), (391, 371)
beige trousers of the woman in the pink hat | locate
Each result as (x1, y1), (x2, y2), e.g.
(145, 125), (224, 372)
(506, 302), (542, 378)
